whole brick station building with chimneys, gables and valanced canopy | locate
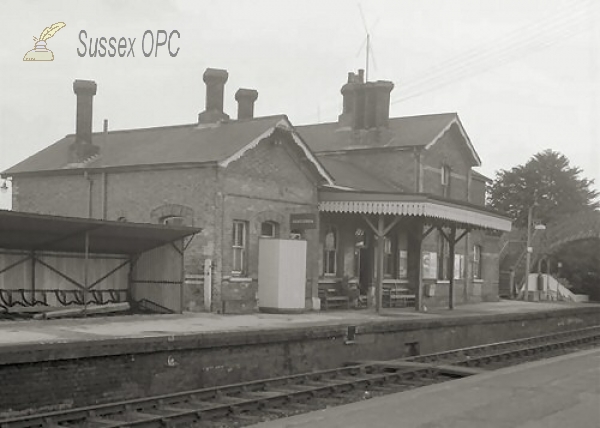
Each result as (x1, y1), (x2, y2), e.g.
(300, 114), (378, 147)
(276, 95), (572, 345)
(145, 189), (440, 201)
(2, 69), (510, 313)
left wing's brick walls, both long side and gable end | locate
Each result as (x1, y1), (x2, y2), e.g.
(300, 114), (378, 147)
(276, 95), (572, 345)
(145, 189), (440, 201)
(13, 135), (326, 310)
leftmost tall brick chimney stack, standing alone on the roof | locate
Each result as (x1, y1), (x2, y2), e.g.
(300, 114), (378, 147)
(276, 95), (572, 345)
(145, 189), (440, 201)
(69, 80), (99, 163)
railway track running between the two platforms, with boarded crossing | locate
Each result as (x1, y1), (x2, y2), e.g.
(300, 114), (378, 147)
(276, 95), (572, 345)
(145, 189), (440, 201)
(0, 326), (600, 428)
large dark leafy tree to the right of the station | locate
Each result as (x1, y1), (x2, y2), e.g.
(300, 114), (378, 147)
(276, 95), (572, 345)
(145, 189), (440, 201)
(488, 149), (600, 227)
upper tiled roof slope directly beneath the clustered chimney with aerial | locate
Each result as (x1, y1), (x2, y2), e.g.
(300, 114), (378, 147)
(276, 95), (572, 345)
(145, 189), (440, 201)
(296, 113), (457, 152)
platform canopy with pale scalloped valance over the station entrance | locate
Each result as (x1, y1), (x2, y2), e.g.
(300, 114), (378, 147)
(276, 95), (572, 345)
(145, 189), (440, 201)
(319, 191), (511, 232)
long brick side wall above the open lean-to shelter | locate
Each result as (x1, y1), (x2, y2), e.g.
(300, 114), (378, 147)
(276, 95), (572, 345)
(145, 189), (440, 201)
(13, 168), (216, 310)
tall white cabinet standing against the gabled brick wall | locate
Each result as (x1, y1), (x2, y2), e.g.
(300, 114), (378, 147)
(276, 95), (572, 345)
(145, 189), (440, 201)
(258, 238), (306, 312)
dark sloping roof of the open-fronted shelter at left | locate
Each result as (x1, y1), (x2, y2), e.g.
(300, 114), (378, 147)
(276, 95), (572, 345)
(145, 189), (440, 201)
(0, 210), (201, 254)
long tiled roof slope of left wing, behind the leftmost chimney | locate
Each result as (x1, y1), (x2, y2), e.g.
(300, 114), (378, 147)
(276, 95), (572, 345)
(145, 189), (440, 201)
(4, 115), (287, 174)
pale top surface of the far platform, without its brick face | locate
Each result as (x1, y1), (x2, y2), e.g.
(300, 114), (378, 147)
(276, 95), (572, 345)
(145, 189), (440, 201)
(0, 300), (600, 351)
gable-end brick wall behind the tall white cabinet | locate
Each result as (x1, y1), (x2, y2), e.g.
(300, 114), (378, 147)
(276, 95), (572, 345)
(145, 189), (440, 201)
(217, 140), (318, 312)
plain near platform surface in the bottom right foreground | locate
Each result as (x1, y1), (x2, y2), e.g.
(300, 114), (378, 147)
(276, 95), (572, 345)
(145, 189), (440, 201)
(253, 349), (600, 428)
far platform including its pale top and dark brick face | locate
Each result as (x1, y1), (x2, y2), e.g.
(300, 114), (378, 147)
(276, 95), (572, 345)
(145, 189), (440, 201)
(0, 301), (600, 416)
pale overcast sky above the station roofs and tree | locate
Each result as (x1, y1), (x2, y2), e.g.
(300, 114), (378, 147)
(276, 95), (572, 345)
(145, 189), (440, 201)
(0, 0), (600, 208)
